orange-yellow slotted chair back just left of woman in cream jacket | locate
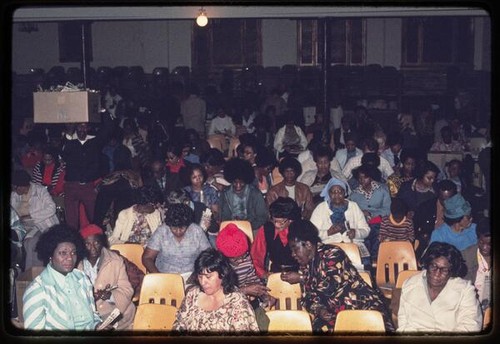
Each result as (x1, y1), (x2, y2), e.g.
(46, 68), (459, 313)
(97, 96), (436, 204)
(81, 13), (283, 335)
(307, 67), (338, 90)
(375, 241), (417, 299)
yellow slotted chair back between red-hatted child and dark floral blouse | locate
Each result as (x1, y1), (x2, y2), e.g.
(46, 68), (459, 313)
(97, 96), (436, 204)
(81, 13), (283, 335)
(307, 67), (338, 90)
(267, 272), (302, 310)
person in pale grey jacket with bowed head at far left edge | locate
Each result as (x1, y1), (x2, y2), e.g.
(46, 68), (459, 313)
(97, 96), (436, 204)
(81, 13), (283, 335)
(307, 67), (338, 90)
(10, 170), (59, 270)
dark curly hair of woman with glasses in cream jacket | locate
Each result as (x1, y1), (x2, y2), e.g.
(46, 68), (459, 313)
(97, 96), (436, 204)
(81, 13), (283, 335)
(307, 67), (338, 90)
(420, 241), (467, 277)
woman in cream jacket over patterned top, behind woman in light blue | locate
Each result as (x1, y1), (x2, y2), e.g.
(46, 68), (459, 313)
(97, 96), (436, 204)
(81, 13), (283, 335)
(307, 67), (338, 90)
(109, 185), (162, 245)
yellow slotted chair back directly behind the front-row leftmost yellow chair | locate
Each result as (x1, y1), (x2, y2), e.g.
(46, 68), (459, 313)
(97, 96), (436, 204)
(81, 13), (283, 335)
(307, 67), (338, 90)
(139, 272), (185, 308)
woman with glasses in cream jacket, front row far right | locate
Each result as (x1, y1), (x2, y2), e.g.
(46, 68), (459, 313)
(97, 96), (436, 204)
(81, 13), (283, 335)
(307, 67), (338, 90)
(397, 242), (483, 334)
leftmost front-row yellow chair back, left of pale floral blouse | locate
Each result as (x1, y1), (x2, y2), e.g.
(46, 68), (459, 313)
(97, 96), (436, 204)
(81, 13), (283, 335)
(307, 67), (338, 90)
(133, 303), (177, 331)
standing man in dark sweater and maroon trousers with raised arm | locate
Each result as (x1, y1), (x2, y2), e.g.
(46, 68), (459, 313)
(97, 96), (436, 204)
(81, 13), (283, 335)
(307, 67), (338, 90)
(62, 111), (114, 230)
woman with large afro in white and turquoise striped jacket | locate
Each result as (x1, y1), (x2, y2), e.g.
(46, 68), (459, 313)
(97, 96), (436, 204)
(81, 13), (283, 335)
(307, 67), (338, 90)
(23, 225), (101, 330)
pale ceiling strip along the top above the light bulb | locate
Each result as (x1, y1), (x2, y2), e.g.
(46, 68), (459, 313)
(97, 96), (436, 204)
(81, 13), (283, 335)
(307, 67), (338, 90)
(12, 6), (488, 22)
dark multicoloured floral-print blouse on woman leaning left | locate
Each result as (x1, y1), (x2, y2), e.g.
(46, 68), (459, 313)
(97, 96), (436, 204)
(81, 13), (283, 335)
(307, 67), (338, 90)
(301, 243), (394, 333)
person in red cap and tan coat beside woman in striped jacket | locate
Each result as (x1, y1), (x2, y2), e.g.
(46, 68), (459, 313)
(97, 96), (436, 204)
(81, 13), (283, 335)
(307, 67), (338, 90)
(78, 224), (135, 330)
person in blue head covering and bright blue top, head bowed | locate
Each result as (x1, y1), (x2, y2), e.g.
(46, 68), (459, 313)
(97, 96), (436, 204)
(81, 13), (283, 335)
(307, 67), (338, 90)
(430, 193), (477, 251)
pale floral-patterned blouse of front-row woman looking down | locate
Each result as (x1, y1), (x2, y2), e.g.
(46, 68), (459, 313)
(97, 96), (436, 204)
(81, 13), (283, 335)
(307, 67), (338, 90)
(172, 287), (259, 335)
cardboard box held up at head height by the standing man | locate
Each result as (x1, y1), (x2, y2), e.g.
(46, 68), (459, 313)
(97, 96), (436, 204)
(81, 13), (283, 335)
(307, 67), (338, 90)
(33, 91), (101, 123)
